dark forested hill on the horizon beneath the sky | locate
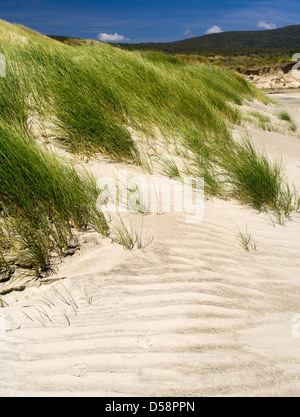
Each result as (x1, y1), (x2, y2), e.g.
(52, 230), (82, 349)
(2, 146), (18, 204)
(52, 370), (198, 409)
(121, 25), (300, 55)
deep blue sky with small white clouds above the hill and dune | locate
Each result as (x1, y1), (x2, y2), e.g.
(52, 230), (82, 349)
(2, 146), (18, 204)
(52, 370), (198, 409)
(0, 0), (300, 43)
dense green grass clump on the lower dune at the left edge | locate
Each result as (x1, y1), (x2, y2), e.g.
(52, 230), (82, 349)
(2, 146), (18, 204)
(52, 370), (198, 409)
(0, 123), (107, 272)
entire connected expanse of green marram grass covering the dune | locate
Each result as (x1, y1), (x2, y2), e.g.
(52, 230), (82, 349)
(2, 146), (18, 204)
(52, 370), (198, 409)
(0, 21), (296, 270)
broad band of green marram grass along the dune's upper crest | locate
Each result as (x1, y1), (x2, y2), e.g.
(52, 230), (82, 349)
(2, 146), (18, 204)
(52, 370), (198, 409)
(0, 20), (267, 163)
